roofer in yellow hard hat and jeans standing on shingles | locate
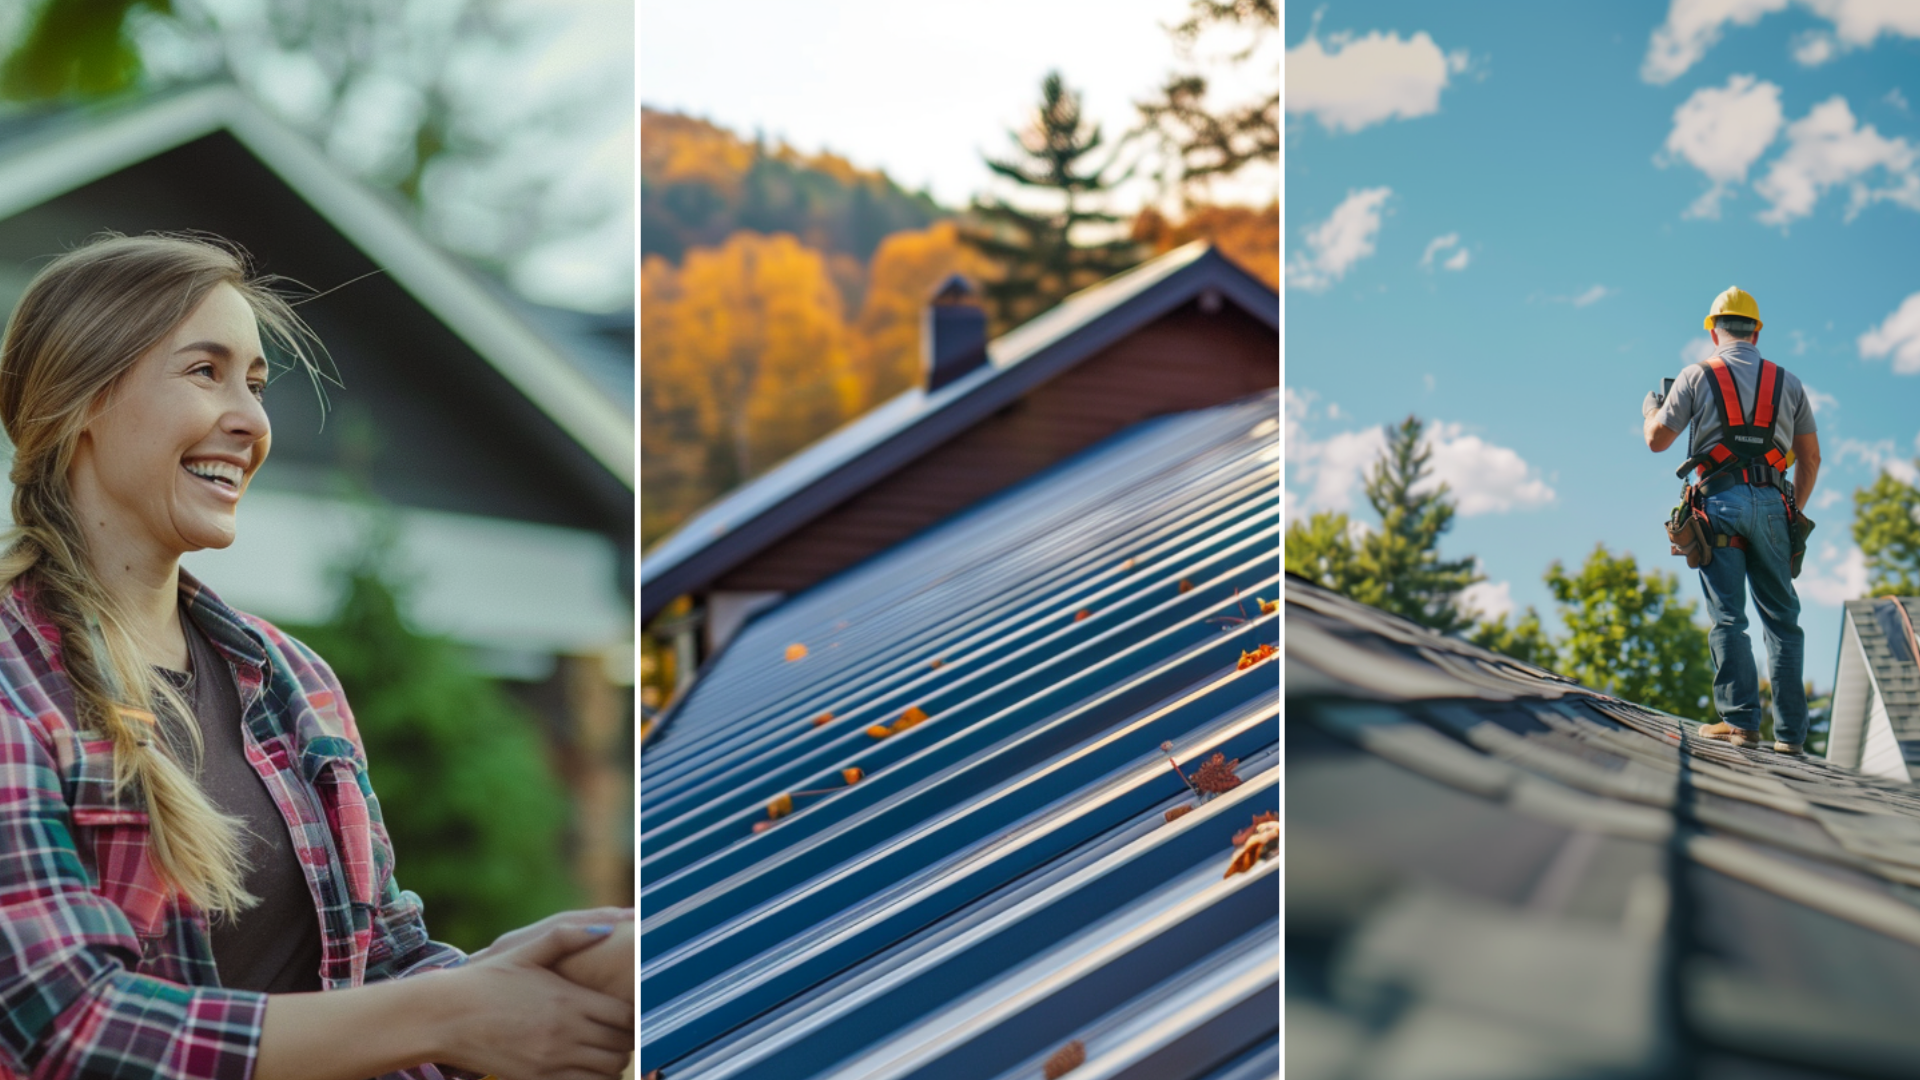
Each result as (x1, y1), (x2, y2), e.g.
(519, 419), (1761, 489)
(1640, 288), (1820, 753)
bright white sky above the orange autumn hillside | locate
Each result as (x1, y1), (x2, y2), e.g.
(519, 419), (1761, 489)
(639, 0), (1277, 209)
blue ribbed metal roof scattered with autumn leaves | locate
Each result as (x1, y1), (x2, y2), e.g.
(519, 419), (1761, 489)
(637, 392), (1281, 1080)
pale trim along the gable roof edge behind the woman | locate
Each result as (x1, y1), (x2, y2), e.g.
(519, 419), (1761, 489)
(0, 85), (634, 490)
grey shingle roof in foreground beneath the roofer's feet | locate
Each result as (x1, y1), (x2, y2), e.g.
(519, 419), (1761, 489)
(1284, 577), (1920, 1076)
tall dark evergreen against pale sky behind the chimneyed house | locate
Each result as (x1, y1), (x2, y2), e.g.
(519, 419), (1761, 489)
(966, 71), (1140, 332)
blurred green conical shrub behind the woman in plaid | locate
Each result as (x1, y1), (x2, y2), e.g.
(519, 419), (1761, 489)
(288, 544), (580, 951)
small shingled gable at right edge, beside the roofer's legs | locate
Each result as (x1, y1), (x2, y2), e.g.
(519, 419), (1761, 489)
(1832, 596), (1920, 780)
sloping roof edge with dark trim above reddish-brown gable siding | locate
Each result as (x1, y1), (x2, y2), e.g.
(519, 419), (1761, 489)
(639, 240), (1279, 623)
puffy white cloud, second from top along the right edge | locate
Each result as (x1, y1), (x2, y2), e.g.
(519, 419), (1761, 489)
(1753, 94), (1920, 225)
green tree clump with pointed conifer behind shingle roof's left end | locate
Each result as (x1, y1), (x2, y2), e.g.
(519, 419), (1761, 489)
(1286, 409), (1482, 634)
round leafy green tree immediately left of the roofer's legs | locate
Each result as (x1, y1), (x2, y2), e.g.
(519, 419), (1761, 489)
(1546, 544), (1713, 719)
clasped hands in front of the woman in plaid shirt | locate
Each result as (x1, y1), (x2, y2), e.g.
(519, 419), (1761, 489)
(437, 922), (634, 1080)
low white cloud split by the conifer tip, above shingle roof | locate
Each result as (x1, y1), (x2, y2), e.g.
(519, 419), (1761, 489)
(1284, 386), (1557, 521)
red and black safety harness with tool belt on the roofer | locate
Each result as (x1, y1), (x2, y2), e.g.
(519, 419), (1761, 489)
(1667, 357), (1812, 577)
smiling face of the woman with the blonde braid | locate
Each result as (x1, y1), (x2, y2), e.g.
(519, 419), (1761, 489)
(69, 284), (271, 557)
